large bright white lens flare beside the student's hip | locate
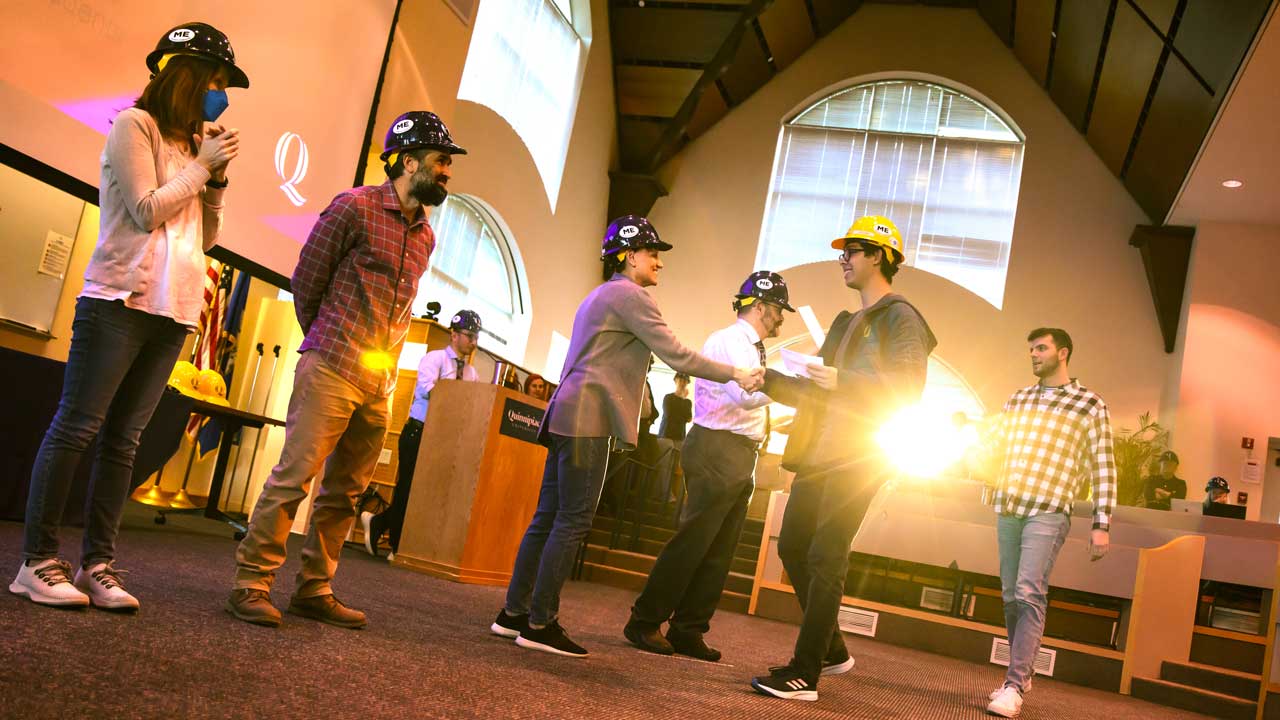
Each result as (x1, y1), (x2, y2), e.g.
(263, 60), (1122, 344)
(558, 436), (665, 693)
(876, 402), (978, 478)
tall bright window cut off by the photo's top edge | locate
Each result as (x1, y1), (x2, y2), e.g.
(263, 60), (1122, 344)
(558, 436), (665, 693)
(458, 0), (585, 211)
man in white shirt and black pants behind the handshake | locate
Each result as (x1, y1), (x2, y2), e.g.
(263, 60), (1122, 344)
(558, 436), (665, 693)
(622, 270), (795, 662)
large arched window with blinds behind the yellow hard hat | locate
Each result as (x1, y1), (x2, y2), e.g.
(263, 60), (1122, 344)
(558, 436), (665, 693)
(755, 81), (1023, 307)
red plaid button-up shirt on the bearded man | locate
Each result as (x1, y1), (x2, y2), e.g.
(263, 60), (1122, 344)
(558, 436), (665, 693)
(292, 182), (435, 395)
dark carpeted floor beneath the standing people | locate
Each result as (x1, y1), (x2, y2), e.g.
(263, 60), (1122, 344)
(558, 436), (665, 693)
(0, 506), (1202, 720)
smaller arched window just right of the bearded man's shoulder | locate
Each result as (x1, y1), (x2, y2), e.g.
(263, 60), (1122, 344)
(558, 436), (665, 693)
(413, 193), (530, 363)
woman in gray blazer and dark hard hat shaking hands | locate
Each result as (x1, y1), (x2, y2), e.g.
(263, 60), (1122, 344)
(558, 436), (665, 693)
(489, 215), (764, 657)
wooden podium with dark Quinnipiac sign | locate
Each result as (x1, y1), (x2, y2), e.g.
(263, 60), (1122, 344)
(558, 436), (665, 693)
(393, 380), (547, 585)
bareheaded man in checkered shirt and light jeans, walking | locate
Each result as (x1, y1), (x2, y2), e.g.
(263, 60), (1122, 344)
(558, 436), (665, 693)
(987, 328), (1116, 717)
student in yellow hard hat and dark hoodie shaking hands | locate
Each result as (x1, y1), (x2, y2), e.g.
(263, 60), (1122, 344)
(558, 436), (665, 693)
(751, 215), (937, 701)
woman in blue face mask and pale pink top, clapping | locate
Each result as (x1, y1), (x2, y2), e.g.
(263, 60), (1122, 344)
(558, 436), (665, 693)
(9, 23), (248, 610)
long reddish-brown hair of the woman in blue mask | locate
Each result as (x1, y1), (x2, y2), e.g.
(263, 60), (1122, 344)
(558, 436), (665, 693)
(133, 55), (219, 155)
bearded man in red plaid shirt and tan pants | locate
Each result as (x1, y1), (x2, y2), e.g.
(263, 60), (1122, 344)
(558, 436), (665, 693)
(225, 111), (466, 628)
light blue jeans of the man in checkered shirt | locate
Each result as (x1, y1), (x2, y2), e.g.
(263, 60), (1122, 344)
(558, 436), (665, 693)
(996, 512), (1071, 692)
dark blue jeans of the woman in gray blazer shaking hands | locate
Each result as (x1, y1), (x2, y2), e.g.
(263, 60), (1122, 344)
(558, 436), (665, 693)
(506, 434), (609, 626)
